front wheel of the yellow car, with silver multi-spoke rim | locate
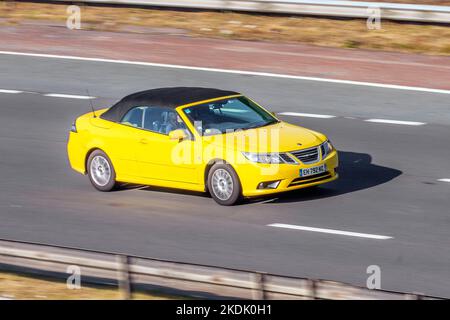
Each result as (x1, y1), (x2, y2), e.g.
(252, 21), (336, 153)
(208, 164), (242, 206)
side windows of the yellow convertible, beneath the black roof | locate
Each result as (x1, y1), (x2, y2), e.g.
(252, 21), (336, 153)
(121, 106), (190, 136)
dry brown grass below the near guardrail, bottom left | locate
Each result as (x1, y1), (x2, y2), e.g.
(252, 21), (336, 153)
(0, 272), (177, 300)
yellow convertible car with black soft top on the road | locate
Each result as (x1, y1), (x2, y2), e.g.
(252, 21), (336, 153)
(68, 87), (338, 205)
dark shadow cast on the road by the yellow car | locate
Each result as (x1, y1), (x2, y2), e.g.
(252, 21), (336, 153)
(251, 151), (402, 203)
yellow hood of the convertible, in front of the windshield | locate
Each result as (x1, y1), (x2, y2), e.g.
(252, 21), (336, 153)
(203, 122), (326, 152)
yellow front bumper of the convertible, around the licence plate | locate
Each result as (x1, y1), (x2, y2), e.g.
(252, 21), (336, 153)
(239, 150), (339, 197)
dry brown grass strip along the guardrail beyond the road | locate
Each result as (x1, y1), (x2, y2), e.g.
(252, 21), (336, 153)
(0, 3), (450, 55)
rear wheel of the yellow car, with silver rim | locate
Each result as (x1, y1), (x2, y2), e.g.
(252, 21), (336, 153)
(87, 150), (116, 192)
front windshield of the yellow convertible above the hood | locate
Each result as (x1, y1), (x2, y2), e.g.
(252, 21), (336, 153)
(183, 96), (279, 136)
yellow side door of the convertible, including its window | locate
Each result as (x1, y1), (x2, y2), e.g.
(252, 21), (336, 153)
(132, 106), (199, 184)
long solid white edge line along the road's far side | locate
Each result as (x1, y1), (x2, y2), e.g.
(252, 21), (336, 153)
(0, 51), (450, 94)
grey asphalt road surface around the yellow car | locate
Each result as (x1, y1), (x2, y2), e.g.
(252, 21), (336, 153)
(0, 55), (450, 297)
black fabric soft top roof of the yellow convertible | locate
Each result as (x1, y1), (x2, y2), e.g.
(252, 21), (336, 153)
(100, 87), (240, 122)
